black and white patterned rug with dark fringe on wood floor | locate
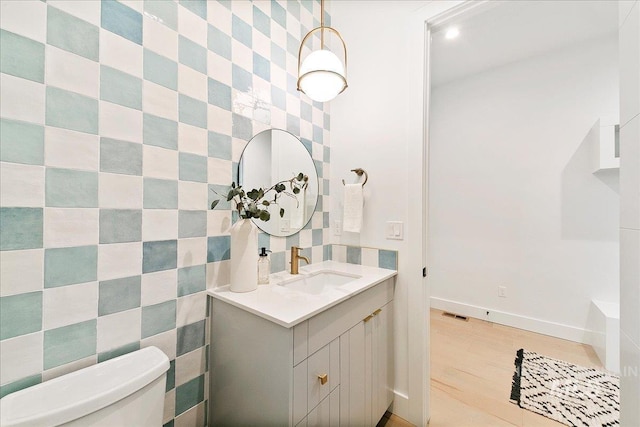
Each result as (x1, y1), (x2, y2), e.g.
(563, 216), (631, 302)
(511, 349), (620, 427)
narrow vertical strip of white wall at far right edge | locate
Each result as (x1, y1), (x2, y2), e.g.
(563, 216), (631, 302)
(619, 0), (640, 427)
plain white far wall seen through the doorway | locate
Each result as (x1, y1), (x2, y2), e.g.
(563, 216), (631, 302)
(428, 36), (619, 339)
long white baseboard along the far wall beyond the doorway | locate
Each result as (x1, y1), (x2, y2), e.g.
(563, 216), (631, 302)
(431, 297), (592, 345)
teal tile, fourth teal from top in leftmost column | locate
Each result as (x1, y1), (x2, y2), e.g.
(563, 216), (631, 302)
(0, 292), (42, 340)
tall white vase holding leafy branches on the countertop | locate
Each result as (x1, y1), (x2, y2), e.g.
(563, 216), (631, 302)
(229, 219), (258, 292)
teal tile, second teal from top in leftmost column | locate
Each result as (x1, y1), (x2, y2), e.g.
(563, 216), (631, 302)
(0, 119), (44, 165)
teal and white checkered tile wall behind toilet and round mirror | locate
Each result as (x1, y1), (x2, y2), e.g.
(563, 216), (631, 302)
(0, 0), (331, 426)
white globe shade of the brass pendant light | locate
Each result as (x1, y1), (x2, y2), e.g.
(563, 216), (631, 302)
(298, 49), (347, 102)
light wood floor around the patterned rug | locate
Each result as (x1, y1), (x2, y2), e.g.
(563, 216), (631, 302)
(378, 310), (602, 427)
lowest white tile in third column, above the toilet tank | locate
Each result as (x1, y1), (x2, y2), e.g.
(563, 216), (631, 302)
(97, 308), (141, 353)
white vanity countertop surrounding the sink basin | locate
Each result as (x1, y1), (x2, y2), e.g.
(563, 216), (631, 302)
(207, 261), (398, 328)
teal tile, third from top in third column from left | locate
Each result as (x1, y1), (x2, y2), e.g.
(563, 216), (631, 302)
(100, 138), (142, 175)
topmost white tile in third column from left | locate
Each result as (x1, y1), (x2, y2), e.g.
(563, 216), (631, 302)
(100, 29), (143, 77)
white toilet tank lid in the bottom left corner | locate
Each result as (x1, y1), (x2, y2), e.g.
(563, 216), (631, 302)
(0, 347), (169, 427)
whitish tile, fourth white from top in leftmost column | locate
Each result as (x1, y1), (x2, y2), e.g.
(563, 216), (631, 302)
(0, 249), (44, 297)
